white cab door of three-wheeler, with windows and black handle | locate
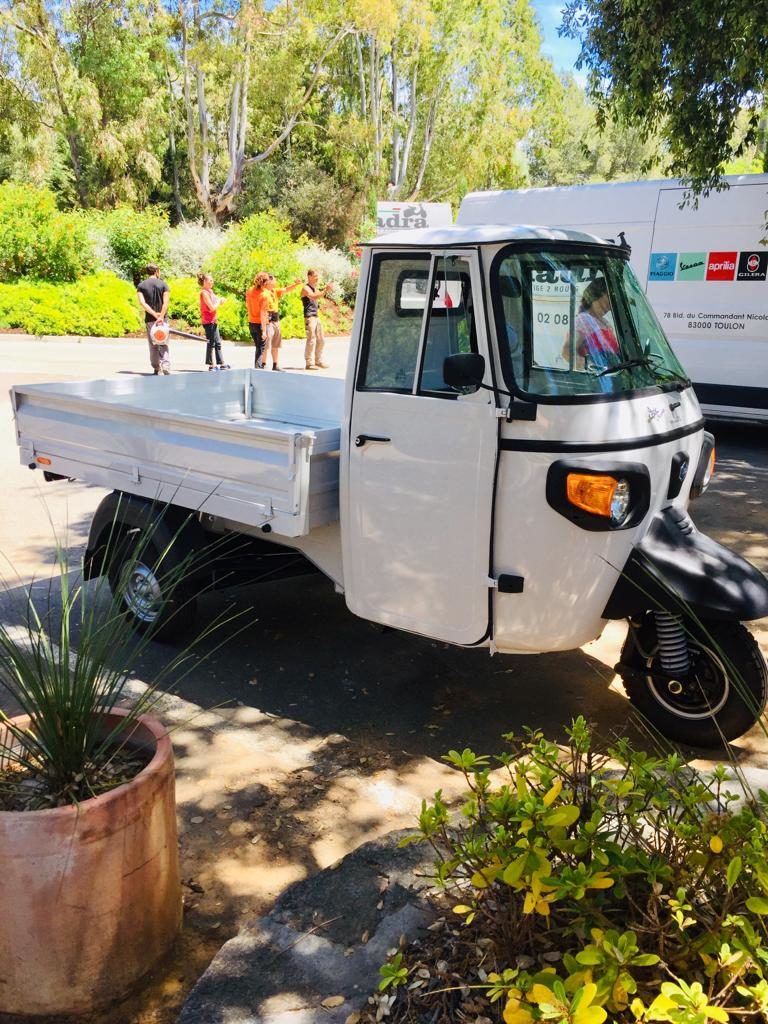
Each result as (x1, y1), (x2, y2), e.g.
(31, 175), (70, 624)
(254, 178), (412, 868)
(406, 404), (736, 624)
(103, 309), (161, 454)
(342, 250), (497, 644)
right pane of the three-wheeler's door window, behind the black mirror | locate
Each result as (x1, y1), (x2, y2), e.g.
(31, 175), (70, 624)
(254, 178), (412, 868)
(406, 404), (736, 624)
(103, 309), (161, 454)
(419, 256), (477, 398)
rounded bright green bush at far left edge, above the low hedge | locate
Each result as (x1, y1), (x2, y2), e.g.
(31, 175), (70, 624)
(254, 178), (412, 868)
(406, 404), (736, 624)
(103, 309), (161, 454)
(0, 181), (94, 281)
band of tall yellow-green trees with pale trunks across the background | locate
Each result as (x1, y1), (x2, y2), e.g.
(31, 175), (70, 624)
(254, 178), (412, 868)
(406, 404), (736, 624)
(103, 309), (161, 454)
(0, 0), (663, 230)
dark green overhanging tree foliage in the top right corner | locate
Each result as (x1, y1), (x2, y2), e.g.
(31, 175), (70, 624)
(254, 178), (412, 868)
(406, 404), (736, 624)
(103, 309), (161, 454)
(562, 0), (768, 191)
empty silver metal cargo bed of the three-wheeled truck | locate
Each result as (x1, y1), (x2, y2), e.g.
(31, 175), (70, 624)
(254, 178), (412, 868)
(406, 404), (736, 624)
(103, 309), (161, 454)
(11, 370), (344, 537)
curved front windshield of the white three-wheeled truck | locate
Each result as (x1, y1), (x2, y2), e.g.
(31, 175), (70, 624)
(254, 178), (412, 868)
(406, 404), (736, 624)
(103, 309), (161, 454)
(493, 251), (690, 398)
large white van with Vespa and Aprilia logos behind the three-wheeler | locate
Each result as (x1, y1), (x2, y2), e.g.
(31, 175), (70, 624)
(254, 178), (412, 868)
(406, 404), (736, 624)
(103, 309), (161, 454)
(458, 174), (768, 422)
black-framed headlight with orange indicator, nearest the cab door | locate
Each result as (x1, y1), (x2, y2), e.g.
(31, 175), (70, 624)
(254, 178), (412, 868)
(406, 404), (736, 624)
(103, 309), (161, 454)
(547, 459), (650, 530)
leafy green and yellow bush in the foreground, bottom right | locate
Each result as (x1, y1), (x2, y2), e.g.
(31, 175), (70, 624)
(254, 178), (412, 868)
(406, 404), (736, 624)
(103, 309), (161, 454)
(380, 719), (768, 1024)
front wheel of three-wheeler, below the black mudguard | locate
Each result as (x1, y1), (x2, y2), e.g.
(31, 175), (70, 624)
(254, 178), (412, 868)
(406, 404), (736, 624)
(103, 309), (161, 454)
(622, 612), (768, 746)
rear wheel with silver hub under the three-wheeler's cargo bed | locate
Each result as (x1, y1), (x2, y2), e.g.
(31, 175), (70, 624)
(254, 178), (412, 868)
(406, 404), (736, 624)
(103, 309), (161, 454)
(108, 532), (197, 641)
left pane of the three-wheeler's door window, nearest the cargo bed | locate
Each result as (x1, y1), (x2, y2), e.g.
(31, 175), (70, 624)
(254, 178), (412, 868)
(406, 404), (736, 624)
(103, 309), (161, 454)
(357, 253), (429, 393)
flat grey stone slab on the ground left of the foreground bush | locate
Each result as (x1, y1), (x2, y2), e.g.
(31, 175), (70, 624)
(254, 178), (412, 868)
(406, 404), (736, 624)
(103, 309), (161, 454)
(177, 830), (434, 1024)
